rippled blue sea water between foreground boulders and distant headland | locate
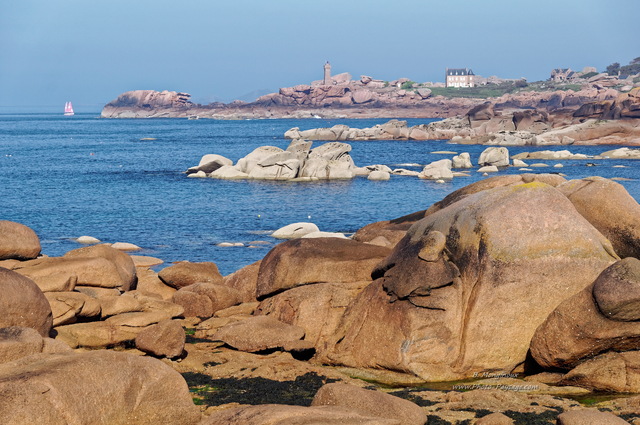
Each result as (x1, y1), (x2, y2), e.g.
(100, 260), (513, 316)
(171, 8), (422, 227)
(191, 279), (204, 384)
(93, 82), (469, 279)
(0, 114), (640, 274)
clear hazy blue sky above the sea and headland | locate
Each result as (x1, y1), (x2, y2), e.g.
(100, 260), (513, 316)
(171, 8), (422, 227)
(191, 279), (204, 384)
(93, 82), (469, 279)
(0, 0), (640, 113)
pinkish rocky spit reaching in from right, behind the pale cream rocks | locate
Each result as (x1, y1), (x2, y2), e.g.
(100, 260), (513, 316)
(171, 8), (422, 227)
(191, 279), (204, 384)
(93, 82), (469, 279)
(285, 88), (640, 146)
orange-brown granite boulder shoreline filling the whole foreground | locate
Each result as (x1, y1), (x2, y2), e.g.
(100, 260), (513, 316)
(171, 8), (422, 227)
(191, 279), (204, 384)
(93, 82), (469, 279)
(0, 173), (640, 425)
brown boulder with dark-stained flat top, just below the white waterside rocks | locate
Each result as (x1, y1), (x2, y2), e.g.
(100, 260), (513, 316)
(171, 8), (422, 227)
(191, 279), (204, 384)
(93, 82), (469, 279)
(256, 238), (389, 299)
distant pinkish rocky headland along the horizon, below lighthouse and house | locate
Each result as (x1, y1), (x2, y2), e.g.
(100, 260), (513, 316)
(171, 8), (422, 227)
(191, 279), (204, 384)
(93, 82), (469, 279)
(101, 68), (636, 119)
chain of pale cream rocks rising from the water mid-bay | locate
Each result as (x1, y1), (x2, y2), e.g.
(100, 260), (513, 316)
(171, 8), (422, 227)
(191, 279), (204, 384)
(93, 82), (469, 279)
(186, 139), (640, 183)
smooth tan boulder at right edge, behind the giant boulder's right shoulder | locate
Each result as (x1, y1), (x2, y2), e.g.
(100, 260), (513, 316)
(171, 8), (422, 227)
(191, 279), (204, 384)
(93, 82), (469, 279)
(558, 177), (640, 258)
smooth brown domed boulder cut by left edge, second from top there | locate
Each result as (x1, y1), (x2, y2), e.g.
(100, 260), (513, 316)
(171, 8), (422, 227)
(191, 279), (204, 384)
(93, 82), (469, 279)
(0, 267), (53, 336)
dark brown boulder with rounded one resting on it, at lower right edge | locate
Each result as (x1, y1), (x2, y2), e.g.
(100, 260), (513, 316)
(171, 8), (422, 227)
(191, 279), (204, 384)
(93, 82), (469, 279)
(531, 258), (640, 369)
